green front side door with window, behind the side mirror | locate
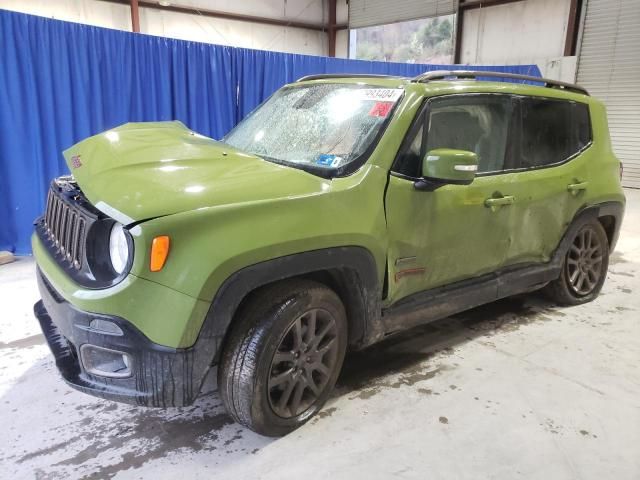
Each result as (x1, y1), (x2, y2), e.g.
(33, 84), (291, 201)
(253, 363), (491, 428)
(386, 94), (516, 304)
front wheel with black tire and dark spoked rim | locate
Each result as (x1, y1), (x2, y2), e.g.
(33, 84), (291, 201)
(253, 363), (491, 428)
(218, 280), (347, 436)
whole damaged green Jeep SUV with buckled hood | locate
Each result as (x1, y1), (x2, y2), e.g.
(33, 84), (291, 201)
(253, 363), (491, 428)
(33, 71), (625, 435)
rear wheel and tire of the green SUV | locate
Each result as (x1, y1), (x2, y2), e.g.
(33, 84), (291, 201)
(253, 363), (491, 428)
(544, 220), (609, 305)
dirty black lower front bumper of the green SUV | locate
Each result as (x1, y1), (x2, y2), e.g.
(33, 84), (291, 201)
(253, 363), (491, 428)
(34, 271), (215, 407)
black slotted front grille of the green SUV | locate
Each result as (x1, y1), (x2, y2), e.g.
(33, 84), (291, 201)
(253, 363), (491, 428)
(44, 186), (87, 270)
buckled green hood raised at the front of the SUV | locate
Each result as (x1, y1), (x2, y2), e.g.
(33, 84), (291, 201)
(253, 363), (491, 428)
(64, 122), (330, 225)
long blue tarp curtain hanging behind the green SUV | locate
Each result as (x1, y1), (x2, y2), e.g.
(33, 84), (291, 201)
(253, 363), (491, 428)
(0, 10), (540, 253)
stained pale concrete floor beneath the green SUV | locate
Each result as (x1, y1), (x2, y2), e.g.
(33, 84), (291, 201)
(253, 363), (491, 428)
(0, 191), (640, 480)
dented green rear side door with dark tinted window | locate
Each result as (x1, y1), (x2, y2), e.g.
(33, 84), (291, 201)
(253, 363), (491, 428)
(505, 97), (592, 264)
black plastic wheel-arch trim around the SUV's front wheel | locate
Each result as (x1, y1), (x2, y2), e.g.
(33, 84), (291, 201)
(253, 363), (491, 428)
(197, 246), (382, 364)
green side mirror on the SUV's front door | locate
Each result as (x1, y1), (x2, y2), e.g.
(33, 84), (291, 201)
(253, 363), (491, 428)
(415, 148), (478, 191)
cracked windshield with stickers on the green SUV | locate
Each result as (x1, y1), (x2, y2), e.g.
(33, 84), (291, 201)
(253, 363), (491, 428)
(223, 83), (402, 172)
